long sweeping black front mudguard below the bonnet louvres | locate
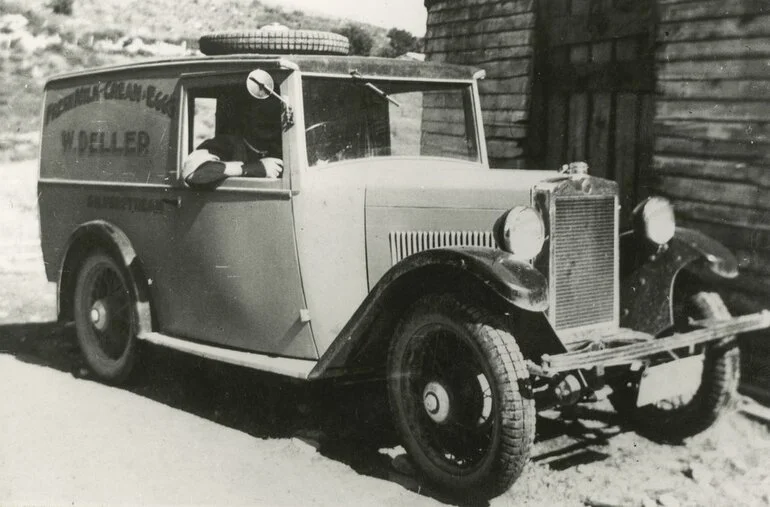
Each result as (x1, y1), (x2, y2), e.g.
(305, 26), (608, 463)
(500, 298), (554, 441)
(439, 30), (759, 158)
(309, 247), (548, 379)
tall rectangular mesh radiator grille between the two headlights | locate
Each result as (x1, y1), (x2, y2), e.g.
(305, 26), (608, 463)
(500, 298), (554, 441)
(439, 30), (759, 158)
(550, 196), (616, 329)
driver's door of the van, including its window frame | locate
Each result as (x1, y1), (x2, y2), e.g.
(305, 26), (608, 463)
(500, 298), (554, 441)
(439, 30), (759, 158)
(148, 73), (318, 358)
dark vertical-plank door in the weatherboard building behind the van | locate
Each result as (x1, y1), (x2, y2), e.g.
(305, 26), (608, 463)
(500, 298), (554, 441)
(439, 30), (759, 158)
(528, 0), (655, 218)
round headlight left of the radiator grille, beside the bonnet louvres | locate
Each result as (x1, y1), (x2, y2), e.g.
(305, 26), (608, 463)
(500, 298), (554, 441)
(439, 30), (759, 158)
(495, 206), (545, 260)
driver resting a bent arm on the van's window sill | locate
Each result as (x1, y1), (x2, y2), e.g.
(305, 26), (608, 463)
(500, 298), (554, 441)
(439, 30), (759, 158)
(182, 92), (283, 187)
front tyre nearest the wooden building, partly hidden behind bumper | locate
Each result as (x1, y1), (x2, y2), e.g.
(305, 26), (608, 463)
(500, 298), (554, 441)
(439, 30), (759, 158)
(610, 292), (740, 442)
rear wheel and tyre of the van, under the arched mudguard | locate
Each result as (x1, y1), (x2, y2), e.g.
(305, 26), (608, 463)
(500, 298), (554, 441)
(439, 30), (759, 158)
(74, 252), (137, 384)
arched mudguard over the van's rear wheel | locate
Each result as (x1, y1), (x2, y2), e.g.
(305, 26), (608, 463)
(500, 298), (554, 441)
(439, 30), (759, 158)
(57, 220), (152, 333)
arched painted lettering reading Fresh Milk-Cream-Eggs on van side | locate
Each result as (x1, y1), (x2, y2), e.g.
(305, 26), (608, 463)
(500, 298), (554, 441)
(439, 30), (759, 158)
(45, 81), (178, 125)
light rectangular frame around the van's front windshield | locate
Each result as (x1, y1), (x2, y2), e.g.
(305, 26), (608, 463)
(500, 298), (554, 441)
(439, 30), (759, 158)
(297, 69), (488, 171)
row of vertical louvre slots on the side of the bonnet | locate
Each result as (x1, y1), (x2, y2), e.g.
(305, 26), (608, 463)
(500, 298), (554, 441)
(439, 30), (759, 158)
(389, 231), (495, 264)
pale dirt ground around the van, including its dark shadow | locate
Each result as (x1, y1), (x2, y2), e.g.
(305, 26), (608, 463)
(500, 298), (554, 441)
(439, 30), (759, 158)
(0, 162), (770, 506)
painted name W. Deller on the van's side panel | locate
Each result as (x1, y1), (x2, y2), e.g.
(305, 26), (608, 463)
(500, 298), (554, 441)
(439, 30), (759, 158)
(61, 130), (151, 157)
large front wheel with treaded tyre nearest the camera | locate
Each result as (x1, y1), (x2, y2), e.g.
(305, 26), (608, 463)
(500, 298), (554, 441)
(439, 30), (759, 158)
(388, 295), (535, 497)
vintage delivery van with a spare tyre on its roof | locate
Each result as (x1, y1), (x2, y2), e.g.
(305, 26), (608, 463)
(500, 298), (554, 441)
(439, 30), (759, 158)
(39, 30), (770, 496)
